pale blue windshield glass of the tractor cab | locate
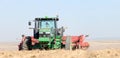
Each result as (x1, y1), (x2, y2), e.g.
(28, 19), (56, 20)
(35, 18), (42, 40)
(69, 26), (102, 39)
(40, 20), (55, 28)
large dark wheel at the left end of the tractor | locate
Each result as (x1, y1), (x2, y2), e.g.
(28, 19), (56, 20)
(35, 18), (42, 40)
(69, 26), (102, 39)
(22, 36), (32, 50)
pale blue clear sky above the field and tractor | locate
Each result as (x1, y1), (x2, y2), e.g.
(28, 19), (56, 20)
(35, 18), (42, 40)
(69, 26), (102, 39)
(0, 0), (120, 42)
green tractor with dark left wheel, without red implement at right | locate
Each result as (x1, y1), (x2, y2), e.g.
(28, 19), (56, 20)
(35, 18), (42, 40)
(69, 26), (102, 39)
(19, 17), (64, 50)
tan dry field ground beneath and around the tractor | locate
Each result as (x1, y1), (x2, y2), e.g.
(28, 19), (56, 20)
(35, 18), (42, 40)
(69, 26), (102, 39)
(0, 41), (120, 58)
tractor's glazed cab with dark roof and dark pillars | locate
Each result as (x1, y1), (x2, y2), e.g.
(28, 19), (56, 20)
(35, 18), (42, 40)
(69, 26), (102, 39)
(34, 18), (59, 39)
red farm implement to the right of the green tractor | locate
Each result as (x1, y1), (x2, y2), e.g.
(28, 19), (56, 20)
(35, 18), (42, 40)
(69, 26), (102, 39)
(62, 35), (89, 49)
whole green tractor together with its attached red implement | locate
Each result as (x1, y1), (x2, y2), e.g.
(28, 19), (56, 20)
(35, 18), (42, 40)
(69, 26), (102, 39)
(18, 17), (89, 50)
